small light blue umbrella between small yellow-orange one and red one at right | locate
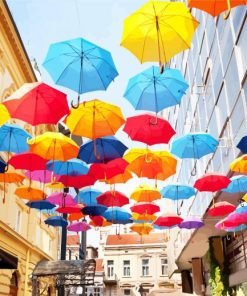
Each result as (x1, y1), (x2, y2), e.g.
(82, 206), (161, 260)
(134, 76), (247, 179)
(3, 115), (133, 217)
(161, 184), (196, 200)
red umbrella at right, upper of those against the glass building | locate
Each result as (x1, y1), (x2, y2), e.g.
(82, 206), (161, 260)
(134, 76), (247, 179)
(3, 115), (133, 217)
(194, 173), (231, 192)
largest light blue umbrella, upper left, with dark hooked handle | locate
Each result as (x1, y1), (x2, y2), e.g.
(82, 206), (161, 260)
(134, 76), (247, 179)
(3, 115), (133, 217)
(43, 38), (118, 106)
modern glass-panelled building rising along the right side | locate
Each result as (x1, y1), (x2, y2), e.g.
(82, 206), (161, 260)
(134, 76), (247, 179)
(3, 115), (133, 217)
(166, 2), (247, 295)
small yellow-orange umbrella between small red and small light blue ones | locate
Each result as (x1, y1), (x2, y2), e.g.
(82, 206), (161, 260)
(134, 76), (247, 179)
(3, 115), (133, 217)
(130, 185), (161, 202)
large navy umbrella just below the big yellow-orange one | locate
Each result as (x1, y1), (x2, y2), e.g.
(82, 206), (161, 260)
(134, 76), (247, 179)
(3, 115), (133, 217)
(78, 137), (128, 163)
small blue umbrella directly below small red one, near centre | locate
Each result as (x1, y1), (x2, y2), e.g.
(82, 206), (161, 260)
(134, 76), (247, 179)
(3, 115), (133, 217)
(102, 207), (132, 224)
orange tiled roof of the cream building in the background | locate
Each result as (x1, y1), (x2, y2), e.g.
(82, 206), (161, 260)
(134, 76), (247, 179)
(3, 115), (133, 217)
(106, 233), (167, 246)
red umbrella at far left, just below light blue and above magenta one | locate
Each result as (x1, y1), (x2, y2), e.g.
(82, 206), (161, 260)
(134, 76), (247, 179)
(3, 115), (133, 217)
(9, 152), (47, 171)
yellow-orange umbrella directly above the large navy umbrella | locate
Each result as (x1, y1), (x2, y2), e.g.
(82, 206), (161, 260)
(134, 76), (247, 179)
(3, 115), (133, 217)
(65, 99), (125, 140)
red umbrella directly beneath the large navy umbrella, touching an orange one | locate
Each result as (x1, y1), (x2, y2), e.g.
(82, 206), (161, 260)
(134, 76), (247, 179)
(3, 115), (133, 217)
(88, 158), (129, 180)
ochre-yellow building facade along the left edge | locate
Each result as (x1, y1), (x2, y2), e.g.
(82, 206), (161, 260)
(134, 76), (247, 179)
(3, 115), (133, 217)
(0, 0), (58, 296)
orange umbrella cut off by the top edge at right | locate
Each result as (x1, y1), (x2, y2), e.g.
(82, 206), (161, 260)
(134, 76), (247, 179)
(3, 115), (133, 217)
(188, 0), (246, 19)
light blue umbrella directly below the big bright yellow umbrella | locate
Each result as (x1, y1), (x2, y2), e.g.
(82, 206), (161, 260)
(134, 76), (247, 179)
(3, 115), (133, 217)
(124, 66), (189, 113)
